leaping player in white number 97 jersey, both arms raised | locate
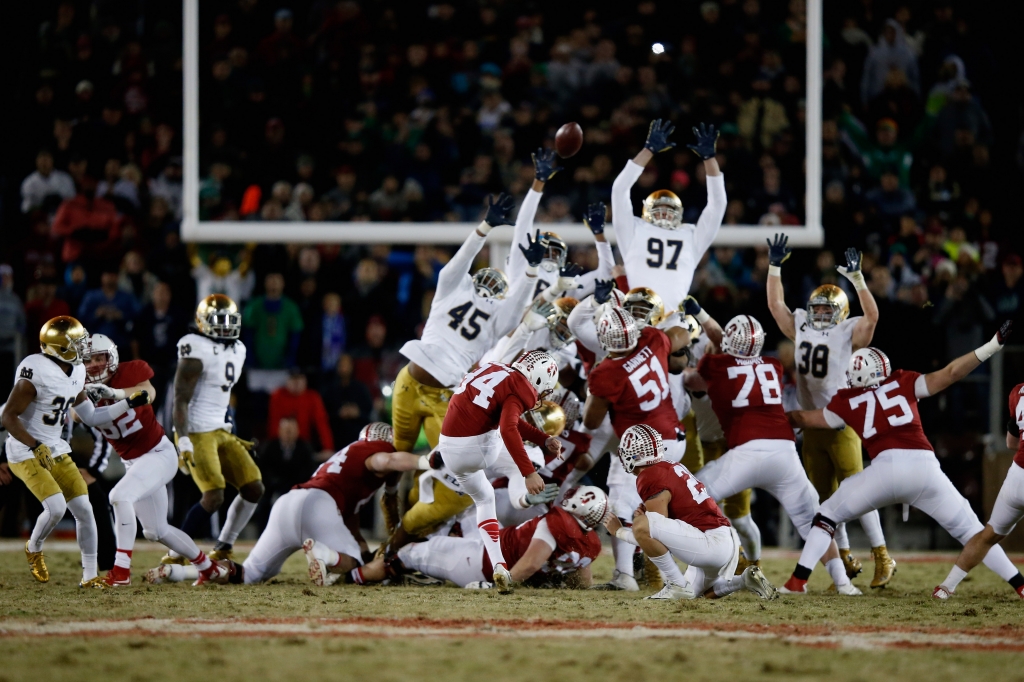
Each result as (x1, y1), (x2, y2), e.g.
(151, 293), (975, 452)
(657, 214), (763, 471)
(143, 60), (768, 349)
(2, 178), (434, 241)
(611, 119), (726, 310)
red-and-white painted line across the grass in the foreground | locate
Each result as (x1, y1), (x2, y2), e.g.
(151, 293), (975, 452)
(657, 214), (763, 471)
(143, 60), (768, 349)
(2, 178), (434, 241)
(0, 619), (1024, 651)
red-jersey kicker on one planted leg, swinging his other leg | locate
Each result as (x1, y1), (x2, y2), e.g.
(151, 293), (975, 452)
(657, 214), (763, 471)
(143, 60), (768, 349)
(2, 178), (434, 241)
(438, 350), (561, 594)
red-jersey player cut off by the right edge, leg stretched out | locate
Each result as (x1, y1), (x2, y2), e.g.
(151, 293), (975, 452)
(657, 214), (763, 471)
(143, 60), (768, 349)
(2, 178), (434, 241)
(932, 384), (1024, 599)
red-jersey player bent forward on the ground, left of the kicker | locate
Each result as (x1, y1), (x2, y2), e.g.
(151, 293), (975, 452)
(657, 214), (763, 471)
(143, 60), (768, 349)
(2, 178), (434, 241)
(147, 422), (421, 586)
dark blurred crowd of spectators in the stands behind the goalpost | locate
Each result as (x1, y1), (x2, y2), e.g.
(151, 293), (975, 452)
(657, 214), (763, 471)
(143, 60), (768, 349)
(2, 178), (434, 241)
(0, 0), (1024, 548)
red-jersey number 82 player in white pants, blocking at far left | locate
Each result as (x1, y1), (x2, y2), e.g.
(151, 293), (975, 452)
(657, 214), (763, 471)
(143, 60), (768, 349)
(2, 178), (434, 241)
(83, 334), (227, 587)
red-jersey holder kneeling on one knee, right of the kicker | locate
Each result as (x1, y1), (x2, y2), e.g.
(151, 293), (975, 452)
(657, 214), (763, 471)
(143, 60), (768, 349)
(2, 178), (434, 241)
(605, 424), (778, 599)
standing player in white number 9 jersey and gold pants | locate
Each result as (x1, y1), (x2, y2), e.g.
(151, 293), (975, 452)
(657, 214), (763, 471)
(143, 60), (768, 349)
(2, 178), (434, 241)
(164, 294), (263, 565)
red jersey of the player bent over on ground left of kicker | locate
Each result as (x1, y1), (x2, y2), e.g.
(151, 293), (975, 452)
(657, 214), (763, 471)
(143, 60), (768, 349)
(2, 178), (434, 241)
(293, 440), (394, 516)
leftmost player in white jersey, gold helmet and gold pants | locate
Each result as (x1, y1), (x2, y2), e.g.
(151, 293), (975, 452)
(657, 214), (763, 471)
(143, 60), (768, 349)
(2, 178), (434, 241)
(0, 315), (150, 589)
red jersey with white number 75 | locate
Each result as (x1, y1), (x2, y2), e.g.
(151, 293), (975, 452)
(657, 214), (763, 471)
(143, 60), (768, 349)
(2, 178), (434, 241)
(825, 370), (934, 460)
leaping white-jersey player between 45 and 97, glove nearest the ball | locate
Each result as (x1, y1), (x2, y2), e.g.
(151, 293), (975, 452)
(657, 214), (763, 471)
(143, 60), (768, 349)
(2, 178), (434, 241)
(507, 148), (615, 300)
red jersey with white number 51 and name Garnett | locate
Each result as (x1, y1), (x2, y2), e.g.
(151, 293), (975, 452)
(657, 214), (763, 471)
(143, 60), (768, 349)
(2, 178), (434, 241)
(587, 327), (679, 440)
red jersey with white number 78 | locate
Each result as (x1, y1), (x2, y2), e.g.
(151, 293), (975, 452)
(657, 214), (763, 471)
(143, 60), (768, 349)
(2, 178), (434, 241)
(697, 353), (795, 447)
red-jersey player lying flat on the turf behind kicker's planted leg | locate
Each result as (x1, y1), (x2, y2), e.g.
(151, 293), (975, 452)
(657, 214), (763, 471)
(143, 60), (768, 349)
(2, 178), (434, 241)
(362, 485), (608, 589)
